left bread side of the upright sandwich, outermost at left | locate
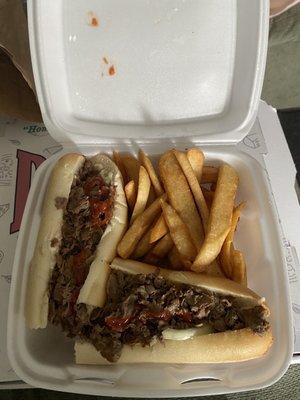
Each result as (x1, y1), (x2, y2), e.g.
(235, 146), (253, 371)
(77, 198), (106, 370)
(26, 153), (85, 329)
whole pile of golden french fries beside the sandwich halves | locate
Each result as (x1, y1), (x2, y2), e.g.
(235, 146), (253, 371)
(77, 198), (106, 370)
(113, 148), (247, 285)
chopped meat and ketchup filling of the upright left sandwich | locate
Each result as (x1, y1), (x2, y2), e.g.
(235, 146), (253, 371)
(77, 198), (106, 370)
(48, 159), (115, 336)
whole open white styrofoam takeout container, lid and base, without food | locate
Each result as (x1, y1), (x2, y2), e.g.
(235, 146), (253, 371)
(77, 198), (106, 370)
(8, 0), (292, 397)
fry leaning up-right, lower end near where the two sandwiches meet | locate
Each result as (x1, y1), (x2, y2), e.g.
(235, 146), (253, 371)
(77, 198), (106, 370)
(117, 194), (167, 258)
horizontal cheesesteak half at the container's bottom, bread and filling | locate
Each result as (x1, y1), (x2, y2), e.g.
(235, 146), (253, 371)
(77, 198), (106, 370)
(75, 258), (273, 364)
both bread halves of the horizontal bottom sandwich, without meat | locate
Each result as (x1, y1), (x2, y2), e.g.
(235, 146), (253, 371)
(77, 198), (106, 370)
(75, 258), (273, 365)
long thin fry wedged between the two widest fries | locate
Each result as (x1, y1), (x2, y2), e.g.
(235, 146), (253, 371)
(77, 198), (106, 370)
(173, 150), (209, 232)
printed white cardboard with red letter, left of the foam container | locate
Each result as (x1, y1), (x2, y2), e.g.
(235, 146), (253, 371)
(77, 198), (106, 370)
(0, 120), (62, 383)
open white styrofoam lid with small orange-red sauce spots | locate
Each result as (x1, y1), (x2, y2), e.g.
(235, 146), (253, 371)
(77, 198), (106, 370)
(28, 0), (268, 144)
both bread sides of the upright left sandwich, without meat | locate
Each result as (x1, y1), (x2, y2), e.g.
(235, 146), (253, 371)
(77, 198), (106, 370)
(26, 153), (127, 329)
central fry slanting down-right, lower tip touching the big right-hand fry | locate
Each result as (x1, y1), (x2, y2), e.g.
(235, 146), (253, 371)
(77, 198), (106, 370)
(160, 200), (197, 262)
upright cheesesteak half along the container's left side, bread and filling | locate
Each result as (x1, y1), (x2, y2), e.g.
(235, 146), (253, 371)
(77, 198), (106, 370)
(26, 153), (127, 337)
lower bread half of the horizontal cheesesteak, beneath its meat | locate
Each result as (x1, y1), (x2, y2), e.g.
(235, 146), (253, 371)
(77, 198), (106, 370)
(75, 328), (273, 365)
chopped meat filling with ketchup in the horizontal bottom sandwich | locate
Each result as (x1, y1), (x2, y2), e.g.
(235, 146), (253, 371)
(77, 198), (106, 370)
(73, 270), (269, 362)
